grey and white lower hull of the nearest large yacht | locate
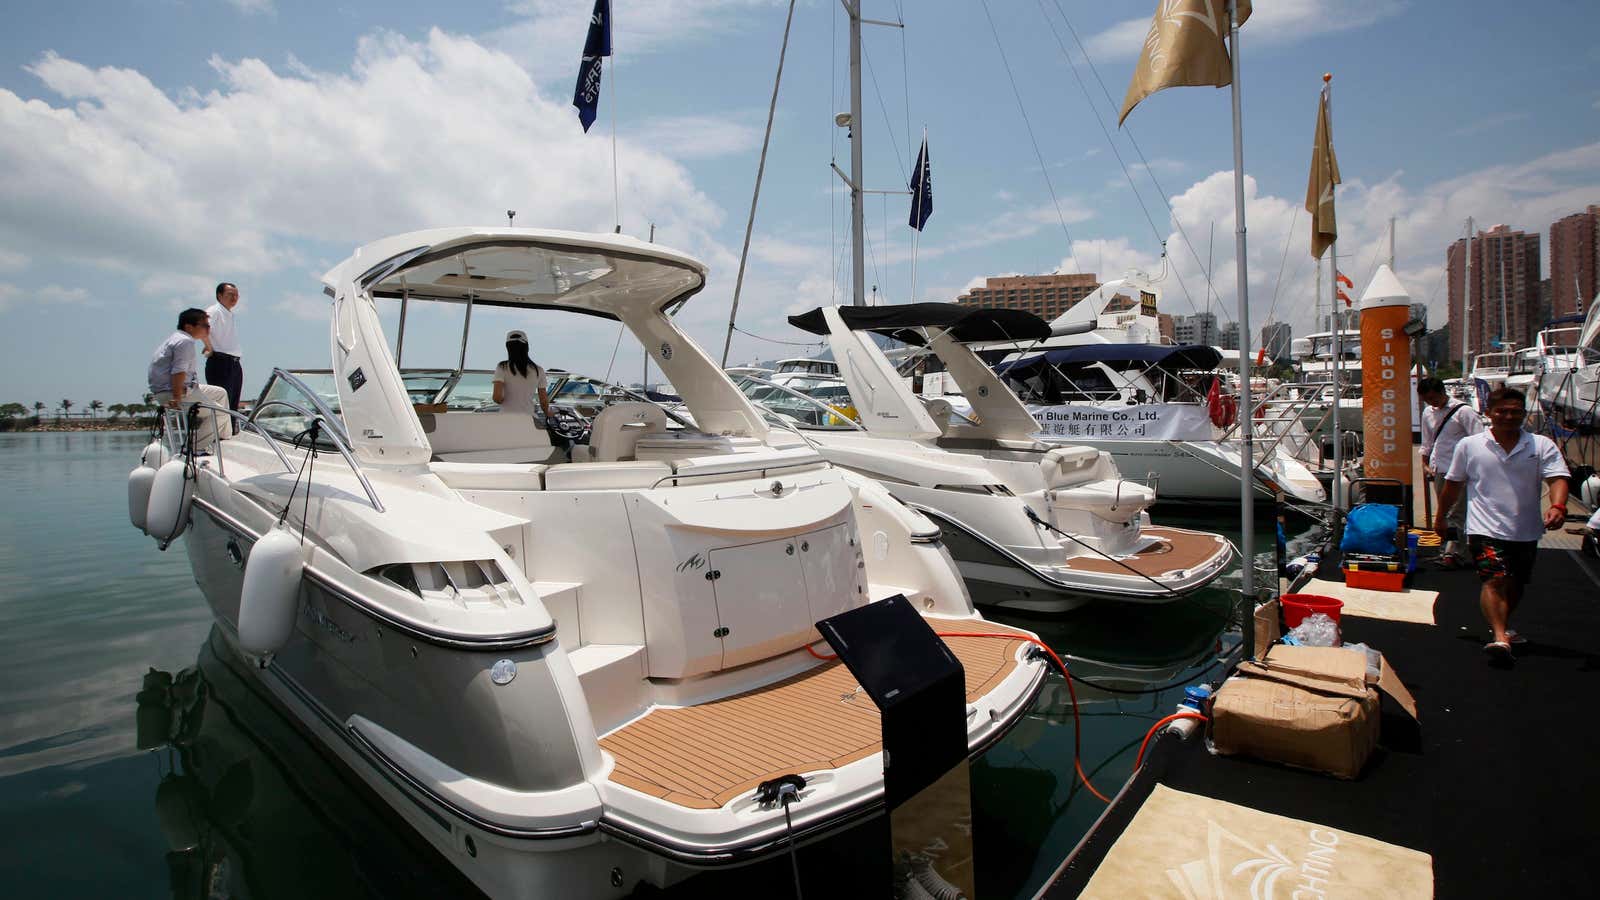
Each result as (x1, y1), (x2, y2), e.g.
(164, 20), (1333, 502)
(182, 492), (1046, 900)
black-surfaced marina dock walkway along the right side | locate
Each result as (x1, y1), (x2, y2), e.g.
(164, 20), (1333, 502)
(1040, 461), (1600, 898)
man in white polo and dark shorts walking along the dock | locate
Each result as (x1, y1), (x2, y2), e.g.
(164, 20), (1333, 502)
(1434, 388), (1568, 663)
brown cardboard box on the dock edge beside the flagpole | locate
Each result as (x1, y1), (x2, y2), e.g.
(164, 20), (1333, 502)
(1211, 644), (1416, 778)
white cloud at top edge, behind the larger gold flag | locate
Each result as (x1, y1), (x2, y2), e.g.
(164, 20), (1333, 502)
(1086, 0), (1406, 62)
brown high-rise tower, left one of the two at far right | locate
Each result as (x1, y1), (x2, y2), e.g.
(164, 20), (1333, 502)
(1445, 226), (1539, 359)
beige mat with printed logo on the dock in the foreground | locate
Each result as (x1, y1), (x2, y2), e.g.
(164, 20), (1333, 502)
(1082, 785), (1434, 900)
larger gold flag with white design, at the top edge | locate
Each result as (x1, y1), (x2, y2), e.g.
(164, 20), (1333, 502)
(1117, 0), (1250, 128)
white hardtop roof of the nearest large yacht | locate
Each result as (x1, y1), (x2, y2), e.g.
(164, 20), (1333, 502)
(322, 227), (707, 319)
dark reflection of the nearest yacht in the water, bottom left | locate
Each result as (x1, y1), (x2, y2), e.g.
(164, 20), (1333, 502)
(134, 628), (478, 900)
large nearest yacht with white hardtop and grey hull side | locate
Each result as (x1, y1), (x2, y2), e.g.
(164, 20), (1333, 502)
(130, 227), (1045, 898)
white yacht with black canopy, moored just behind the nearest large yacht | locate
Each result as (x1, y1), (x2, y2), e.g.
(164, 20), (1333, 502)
(755, 303), (1234, 612)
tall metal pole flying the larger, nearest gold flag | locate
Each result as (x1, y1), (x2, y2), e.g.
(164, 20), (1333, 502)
(1227, 0), (1256, 658)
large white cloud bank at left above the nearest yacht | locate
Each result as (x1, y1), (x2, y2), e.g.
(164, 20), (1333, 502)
(0, 30), (720, 283)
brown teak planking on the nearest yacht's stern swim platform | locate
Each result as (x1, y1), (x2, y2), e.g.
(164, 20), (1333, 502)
(600, 617), (1022, 809)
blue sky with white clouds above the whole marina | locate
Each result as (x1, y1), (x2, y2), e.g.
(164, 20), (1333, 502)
(0, 0), (1600, 407)
